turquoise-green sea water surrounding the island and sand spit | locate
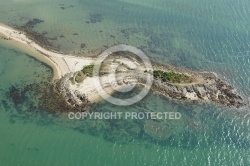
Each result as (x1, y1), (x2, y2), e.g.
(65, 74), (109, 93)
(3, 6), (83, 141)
(0, 0), (250, 166)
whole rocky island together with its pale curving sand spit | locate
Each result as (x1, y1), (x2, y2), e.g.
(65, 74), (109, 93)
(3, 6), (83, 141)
(0, 22), (245, 111)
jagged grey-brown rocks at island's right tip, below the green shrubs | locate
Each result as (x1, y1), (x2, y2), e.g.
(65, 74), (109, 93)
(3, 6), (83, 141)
(152, 72), (245, 108)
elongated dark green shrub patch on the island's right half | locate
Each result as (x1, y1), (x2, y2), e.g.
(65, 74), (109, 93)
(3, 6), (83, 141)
(153, 70), (192, 83)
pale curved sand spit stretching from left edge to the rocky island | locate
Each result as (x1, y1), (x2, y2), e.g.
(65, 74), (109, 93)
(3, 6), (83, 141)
(0, 23), (94, 80)
